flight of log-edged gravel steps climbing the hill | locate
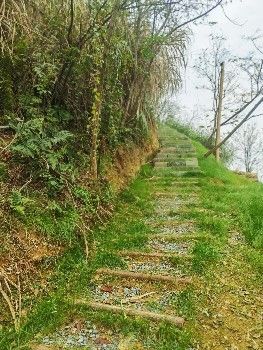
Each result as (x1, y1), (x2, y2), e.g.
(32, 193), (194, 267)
(36, 128), (202, 349)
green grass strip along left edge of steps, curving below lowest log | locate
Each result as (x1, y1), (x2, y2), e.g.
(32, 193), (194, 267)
(0, 167), (190, 350)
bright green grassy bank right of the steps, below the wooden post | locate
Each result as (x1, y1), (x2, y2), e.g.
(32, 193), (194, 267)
(167, 123), (263, 276)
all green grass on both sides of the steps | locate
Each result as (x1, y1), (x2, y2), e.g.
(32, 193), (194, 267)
(0, 125), (263, 350)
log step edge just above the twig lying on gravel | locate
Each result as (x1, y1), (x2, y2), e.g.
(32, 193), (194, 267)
(96, 268), (192, 285)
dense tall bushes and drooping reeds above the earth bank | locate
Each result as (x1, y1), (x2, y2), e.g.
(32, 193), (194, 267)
(0, 0), (192, 191)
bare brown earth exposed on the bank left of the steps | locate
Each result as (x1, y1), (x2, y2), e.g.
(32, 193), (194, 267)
(0, 129), (158, 325)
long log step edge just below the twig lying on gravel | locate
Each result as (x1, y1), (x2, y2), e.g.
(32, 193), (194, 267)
(74, 299), (185, 327)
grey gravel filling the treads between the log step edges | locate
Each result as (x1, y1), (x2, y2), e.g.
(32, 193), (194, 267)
(34, 129), (198, 350)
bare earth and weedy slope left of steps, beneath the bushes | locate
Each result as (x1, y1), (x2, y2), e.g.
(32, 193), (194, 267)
(0, 130), (158, 326)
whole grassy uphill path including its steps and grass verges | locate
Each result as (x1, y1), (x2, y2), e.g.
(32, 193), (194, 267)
(0, 128), (263, 350)
